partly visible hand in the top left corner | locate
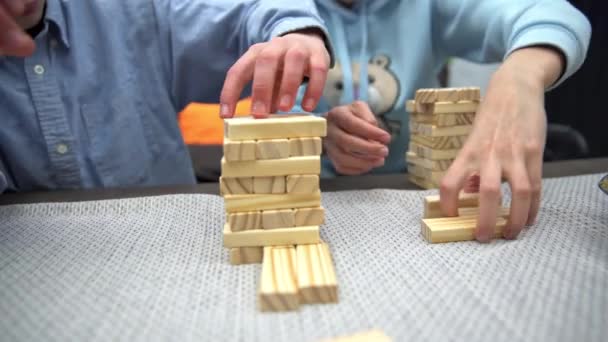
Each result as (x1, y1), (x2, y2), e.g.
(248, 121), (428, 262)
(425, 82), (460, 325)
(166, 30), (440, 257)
(0, 0), (34, 57)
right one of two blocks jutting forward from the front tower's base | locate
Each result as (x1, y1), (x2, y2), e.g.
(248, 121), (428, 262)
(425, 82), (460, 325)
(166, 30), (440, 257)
(296, 242), (338, 304)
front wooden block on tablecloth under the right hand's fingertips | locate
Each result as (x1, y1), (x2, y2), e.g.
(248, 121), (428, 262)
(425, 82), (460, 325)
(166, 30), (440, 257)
(422, 215), (507, 243)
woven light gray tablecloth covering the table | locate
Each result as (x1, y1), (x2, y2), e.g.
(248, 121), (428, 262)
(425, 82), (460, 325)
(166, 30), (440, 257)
(0, 175), (608, 341)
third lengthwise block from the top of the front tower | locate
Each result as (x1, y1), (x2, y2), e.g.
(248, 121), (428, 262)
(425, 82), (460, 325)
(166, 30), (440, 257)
(224, 192), (321, 213)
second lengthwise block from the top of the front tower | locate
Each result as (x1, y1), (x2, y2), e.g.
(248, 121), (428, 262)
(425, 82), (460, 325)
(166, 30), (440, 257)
(222, 156), (321, 177)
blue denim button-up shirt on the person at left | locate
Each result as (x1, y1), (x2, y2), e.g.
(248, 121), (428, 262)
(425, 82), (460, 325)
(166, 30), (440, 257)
(0, 0), (322, 192)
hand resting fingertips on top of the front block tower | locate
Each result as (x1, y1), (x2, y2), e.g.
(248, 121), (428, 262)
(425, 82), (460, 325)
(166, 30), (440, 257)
(220, 30), (330, 118)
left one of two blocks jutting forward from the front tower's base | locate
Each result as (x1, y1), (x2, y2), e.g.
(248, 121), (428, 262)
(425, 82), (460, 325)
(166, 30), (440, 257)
(258, 246), (300, 312)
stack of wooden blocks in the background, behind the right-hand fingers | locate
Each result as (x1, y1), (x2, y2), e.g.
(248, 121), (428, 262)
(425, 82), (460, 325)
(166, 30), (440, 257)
(406, 87), (480, 189)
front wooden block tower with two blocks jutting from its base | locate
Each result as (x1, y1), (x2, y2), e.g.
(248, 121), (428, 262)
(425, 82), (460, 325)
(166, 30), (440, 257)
(220, 115), (338, 311)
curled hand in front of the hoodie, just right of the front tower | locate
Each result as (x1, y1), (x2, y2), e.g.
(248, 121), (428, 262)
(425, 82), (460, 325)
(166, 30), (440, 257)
(323, 101), (391, 175)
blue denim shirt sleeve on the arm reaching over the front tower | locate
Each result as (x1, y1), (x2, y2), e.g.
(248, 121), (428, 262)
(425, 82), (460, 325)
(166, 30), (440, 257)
(154, 0), (328, 110)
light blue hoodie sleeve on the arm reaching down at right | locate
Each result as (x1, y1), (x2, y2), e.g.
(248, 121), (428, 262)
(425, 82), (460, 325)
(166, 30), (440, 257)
(432, 0), (591, 86)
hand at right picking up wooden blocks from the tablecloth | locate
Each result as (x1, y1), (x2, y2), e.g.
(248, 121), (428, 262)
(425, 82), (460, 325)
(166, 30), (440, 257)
(440, 47), (563, 242)
